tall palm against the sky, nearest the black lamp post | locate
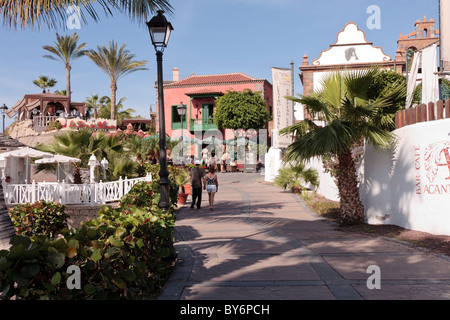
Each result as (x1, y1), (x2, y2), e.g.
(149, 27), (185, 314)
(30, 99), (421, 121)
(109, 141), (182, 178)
(86, 41), (148, 120)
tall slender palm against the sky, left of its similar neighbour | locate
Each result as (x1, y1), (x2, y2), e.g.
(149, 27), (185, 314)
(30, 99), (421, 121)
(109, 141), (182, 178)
(42, 33), (87, 100)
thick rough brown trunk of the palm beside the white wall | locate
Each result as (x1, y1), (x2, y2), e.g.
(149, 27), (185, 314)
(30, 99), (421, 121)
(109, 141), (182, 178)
(337, 149), (365, 225)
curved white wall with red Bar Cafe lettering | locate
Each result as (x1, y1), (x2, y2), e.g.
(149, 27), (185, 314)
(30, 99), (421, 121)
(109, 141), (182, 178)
(361, 119), (450, 235)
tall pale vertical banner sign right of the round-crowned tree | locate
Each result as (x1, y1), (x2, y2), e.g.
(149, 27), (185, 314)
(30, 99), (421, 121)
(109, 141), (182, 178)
(272, 68), (294, 148)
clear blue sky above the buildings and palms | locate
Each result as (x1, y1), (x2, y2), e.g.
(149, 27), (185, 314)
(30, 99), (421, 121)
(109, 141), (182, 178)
(0, 0), (439, 126)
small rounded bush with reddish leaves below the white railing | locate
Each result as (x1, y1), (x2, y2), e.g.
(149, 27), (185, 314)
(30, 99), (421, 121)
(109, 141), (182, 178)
(10, 201), (68, 238)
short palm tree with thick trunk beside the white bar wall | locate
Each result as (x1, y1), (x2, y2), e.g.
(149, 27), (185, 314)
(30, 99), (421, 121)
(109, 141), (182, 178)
(282, 69), (406, 224)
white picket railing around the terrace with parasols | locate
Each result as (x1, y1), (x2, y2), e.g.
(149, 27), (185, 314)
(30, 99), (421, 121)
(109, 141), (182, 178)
(3, 173), (152, 205)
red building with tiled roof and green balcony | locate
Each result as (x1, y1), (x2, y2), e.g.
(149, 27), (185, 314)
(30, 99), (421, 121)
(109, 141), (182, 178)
(156, 68), (273, 160)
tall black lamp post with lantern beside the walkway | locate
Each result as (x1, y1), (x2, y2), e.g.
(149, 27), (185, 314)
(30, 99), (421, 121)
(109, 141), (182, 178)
(147, 10), (173, 210)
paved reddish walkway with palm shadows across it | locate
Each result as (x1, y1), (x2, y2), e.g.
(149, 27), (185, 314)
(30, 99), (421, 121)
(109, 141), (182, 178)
(159, 173), (450, 300)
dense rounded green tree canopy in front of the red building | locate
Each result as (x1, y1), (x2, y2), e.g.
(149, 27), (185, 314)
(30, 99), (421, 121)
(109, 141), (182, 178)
(214, 89), (269, 130)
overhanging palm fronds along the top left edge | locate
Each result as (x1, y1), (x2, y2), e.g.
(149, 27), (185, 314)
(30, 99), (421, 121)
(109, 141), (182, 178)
(0, 0), (173, 29)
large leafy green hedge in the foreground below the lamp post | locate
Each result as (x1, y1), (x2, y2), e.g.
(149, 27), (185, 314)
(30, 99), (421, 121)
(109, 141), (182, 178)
(0, 183), (175, 300)
